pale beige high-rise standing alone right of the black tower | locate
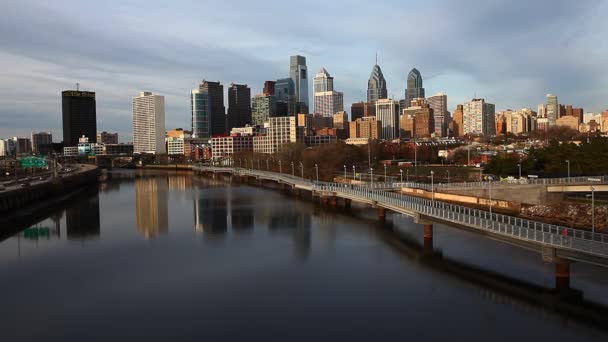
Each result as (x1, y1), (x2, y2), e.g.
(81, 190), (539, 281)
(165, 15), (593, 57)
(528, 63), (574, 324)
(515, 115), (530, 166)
(133, 91), (166, 154)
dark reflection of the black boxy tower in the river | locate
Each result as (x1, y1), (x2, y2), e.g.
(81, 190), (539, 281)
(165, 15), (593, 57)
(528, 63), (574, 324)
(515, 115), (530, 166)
(65, 189), (101, 240)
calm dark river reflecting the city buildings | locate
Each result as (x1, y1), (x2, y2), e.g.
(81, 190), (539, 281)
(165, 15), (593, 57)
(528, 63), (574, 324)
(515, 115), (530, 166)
(0, 171), (608, 342)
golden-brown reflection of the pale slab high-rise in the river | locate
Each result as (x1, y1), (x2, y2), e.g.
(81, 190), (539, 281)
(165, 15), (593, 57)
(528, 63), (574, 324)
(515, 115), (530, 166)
(135, 176), (169, 239)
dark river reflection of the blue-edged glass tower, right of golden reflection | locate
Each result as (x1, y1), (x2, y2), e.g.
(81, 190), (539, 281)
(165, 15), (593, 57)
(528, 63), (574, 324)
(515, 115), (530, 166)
(194, 190), (228, 237)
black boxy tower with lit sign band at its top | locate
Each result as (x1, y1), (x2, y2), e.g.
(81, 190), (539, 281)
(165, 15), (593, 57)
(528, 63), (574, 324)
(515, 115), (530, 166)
(61, 90), (97, 146)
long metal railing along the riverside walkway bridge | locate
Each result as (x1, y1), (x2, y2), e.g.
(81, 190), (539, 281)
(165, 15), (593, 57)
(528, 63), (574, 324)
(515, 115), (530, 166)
(314, 184), (608, 257)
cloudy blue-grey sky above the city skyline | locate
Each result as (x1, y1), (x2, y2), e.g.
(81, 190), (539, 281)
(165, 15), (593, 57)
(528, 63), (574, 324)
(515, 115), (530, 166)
(0, 0), (608, 142)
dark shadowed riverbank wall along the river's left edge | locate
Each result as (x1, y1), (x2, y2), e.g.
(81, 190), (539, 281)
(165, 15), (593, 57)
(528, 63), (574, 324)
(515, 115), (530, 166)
(0, 165), (101, 220)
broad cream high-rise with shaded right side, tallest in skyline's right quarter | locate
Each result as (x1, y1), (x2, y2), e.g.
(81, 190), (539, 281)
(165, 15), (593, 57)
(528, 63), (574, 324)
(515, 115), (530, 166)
(463, 99), (496, 136)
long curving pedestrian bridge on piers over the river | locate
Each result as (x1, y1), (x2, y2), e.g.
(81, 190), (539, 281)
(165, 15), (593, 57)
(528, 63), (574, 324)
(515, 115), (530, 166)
(193, 165), (608, 289)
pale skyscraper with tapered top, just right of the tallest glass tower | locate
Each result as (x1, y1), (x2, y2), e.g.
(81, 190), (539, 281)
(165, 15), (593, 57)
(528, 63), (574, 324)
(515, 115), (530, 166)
(314, 68), (344, 117)
